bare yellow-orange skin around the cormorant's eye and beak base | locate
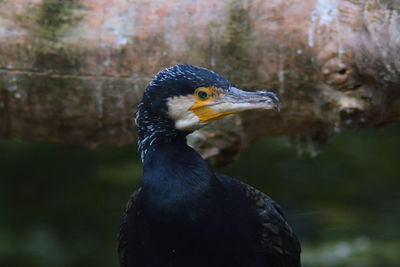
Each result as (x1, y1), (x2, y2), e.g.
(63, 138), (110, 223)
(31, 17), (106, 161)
(189, 87), (236, 122)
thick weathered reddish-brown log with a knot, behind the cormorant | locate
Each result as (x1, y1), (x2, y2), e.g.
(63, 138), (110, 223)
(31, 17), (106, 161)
(0, 0), (400, 163)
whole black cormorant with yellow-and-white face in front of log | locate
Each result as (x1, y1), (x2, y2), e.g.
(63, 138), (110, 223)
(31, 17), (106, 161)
(118, 65), (301, 267)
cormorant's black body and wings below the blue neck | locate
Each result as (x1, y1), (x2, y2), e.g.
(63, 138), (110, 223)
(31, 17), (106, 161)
(119, 174), (300, 267)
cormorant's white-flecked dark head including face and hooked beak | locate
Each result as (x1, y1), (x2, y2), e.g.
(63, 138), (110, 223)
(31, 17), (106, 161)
(136, 65), (279, 149)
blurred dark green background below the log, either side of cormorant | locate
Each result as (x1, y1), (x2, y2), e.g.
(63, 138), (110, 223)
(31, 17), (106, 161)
(0, 126), (400, 267)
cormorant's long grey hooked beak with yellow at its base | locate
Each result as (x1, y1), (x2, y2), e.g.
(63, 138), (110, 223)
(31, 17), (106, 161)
(193, 86), (280, 122)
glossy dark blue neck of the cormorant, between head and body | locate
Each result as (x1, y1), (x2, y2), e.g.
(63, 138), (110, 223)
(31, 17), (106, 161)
(142, 136), (215, 218)
